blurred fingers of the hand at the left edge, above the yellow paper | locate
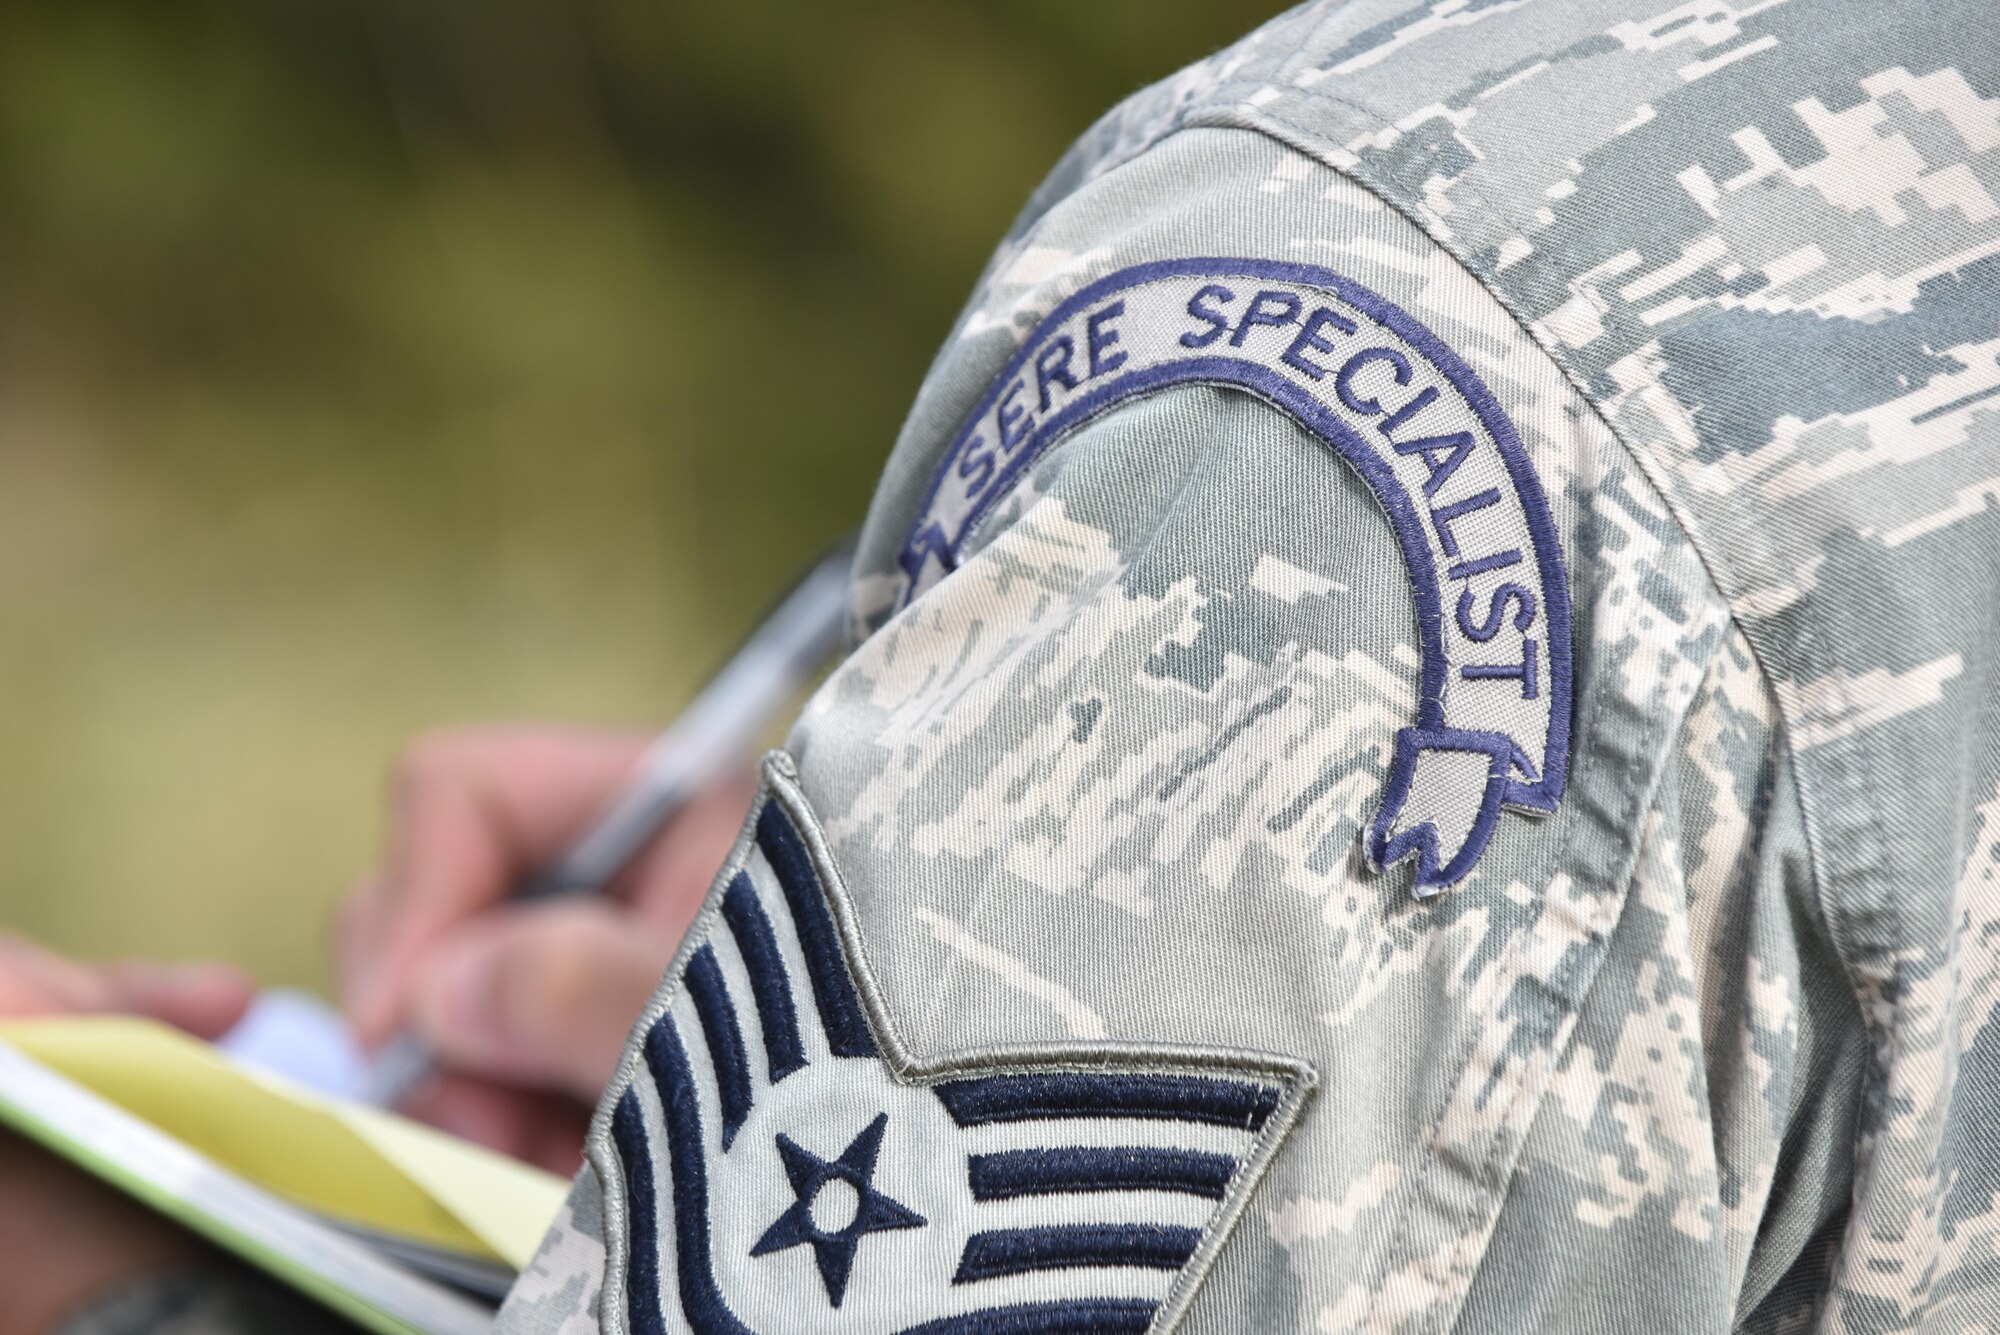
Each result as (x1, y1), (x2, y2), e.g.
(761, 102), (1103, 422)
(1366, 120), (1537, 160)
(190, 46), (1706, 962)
(0, 931), (256, 1039)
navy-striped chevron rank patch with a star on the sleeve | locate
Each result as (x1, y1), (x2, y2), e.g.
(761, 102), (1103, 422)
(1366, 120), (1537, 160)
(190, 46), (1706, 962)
(592, 777), (1312, 1335)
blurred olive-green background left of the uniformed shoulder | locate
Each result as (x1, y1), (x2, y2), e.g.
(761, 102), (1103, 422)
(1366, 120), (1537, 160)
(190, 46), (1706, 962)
(0, 0), (1276, 985)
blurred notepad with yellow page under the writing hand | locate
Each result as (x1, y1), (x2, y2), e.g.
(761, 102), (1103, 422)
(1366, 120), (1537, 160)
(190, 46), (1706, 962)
(0, 1015), (568, 1327)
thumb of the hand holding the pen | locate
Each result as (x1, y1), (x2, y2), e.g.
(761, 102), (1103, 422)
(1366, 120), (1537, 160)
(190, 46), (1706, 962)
(412, 901), (674, 1101)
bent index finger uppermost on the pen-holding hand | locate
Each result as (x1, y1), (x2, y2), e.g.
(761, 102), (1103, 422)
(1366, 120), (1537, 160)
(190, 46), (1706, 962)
(342, 727), (646, 1041)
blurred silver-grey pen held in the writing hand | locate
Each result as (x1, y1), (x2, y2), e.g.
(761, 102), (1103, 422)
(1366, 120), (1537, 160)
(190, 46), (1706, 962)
(368, 536), (854, 1107)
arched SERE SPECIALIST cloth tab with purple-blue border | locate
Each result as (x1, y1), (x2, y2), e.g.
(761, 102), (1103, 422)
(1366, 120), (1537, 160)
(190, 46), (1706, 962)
(900, 260), (1570, 895)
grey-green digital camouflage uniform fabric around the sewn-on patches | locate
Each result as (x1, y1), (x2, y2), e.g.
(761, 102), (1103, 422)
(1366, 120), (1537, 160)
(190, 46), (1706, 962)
(488, 0), (2000, 1335)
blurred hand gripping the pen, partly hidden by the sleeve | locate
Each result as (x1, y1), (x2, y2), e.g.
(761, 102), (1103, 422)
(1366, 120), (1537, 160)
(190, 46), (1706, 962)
(338, 725), (754, 1171)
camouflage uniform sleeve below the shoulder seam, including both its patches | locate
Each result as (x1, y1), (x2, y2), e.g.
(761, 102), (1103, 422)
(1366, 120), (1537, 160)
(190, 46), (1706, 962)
(502, 119), (1864, 1335)
